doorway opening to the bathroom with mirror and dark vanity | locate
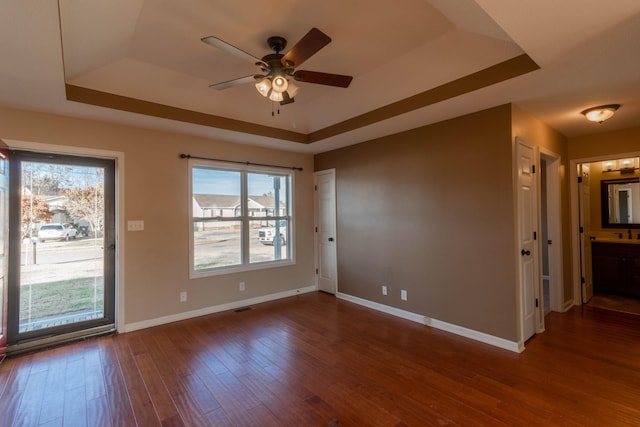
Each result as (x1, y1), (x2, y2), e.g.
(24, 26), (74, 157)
(572, 153), (640, 314)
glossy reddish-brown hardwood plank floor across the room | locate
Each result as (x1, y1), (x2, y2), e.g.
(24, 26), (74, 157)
(0, 293), (640, 427)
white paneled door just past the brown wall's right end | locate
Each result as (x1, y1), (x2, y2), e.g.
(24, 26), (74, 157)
(517, 140), (540, 342)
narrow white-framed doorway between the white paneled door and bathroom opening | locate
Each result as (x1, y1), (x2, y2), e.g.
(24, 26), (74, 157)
(538, 147), (564, 314)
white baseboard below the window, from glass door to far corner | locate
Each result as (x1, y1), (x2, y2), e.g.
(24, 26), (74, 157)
(119, 286), (318, 332)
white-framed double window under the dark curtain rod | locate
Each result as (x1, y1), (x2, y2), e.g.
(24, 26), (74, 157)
(190, 160), (293, 277)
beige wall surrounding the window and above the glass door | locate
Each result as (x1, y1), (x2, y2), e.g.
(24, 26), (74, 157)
(0, 109), (315, 324)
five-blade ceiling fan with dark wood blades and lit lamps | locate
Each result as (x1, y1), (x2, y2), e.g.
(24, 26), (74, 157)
(202, 28), (353, 105)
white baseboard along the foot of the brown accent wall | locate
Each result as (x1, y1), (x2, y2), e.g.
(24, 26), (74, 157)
(336, 292), (524, 353)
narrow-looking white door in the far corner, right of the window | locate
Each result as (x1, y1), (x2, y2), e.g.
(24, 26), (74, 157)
(314, 169), (338, 294)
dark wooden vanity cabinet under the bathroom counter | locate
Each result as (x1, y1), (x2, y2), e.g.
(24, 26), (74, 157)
(591, 242), (640, 296)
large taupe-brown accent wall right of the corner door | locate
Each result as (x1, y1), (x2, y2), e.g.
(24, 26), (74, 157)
(314, 105), (519, 341)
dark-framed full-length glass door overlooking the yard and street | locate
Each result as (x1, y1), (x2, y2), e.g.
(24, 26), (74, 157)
(8, 151), (115, 345)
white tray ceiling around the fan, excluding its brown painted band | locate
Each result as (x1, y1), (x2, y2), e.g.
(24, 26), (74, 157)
(0, 0), (640, 153)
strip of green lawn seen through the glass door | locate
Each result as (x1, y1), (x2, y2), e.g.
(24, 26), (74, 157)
(20, 277), (104, 320)
